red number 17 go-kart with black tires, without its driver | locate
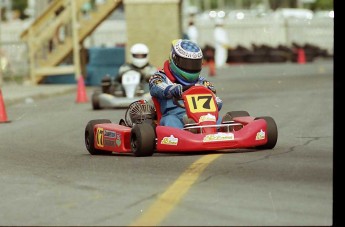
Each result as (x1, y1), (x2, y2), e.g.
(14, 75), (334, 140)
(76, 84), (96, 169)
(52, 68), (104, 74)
(84, 86), (278, 156)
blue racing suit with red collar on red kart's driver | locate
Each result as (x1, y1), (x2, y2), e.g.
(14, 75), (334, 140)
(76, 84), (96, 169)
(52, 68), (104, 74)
(149, 60), (223, 128)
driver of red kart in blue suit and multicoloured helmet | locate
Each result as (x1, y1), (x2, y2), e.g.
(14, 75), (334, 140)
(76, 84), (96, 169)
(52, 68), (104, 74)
(149, 39), (223, 128)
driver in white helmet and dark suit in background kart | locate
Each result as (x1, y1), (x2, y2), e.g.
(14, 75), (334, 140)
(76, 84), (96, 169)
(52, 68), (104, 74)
(102, 43), (157, 96)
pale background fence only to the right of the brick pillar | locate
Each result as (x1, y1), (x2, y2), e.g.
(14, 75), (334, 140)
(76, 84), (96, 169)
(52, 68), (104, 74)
(195, 14), (334, 54)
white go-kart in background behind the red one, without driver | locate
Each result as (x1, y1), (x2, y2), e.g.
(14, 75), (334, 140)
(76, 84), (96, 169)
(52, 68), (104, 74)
(91, 70), (151, 110)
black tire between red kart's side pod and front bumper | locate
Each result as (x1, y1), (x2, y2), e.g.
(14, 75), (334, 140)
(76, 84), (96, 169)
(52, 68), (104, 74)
(131, 122), (156, 157)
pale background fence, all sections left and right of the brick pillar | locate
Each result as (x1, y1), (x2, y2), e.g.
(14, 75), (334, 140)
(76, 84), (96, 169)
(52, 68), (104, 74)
(0, 15), (334, 80)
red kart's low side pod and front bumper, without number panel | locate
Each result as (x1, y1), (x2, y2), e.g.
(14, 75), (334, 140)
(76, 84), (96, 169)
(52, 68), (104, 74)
(94, 117), (267, 153)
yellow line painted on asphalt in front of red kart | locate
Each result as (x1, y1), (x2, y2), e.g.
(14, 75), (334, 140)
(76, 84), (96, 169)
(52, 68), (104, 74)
(131, 154), (222, 226)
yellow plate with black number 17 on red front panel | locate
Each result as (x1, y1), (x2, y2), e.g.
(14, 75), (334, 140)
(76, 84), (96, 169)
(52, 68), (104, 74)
(187, 94), (216, 113)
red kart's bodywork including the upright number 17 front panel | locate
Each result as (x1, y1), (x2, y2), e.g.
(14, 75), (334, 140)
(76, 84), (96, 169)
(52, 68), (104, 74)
(94, 86), (267, 153)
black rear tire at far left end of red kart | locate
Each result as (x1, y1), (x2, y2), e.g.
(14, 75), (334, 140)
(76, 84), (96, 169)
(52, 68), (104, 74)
(85, 119), (111, 155)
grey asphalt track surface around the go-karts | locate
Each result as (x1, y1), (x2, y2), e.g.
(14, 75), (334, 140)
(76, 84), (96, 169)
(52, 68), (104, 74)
(0, 61), (333, 226)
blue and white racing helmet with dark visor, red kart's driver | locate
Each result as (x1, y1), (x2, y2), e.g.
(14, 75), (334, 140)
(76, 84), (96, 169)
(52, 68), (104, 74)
(169, 39), (203, 85)
